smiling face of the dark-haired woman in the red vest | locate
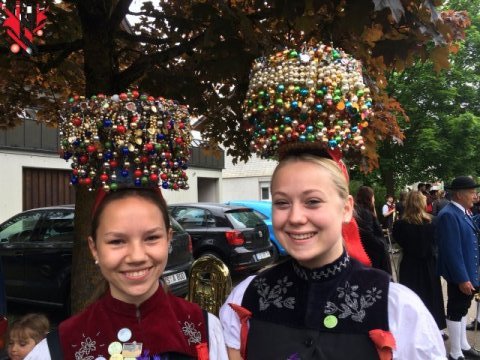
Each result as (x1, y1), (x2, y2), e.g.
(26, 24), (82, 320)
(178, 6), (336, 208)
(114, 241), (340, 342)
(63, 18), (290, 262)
(88, 196), (172, 305)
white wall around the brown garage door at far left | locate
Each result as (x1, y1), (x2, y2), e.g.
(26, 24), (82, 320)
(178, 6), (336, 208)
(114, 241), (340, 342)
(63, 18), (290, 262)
(0, 151), (71, 222)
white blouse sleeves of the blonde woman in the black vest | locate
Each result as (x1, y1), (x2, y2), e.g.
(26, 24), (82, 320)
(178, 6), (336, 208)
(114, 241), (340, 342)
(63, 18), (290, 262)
(220, 276), (446, 360)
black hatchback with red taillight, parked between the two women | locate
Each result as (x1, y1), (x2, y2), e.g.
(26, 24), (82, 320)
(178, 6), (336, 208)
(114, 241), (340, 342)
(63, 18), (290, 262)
(169, 203), (274, 273)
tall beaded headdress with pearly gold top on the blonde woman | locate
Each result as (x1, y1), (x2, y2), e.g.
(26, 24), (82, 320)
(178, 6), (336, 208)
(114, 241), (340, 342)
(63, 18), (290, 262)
(243, 44), (373, 158)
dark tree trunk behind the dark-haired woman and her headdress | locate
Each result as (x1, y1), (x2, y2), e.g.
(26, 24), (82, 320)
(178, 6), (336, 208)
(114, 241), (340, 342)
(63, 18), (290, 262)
(71, 0), (118, 313)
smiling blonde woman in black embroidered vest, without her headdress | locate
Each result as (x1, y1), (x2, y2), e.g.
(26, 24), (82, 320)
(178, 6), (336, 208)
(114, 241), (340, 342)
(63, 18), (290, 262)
(220, 143), (445, 360)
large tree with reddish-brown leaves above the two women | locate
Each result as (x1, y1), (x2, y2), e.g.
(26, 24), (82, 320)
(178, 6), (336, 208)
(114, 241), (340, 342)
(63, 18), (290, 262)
(0, 0), (469, 310)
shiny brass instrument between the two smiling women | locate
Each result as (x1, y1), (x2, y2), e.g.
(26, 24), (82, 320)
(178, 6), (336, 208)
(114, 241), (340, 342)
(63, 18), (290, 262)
(187, 254), (232, 315)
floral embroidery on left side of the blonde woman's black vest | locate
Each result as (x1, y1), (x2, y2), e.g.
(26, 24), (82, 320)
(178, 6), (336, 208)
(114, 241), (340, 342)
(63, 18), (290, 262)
(253, 276), (295, 311)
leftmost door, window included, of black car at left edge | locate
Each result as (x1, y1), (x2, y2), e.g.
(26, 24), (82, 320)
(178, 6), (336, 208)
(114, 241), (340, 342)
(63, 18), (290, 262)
(0, 211), (42, 299)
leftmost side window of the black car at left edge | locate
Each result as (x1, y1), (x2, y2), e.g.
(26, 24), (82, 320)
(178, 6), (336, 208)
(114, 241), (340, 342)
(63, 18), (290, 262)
(0, 212), (41, 243)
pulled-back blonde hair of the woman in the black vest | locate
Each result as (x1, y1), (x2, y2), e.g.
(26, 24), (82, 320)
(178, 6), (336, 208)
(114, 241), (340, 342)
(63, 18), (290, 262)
(272, 153), (349, 201)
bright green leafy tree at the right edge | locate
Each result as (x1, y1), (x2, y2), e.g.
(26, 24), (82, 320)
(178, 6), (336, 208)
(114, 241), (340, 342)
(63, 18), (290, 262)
(379, 1), (480, 191)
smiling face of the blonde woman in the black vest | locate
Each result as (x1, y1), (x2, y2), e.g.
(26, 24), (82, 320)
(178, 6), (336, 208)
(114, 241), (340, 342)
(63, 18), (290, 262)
(272, 159), (353, 268)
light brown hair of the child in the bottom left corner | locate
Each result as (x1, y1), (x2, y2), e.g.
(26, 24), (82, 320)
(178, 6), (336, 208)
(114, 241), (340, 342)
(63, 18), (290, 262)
(8, 313), (50, 344)
